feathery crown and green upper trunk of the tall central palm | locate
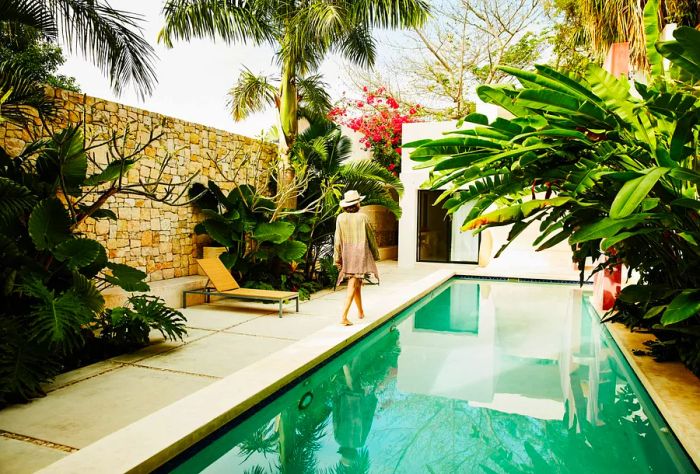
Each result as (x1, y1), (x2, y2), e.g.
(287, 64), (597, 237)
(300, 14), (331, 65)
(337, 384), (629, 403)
(158, 0), (428, 155)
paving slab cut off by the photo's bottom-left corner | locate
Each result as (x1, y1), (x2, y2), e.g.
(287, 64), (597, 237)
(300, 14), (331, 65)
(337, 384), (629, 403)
(0, 436), (69, 474)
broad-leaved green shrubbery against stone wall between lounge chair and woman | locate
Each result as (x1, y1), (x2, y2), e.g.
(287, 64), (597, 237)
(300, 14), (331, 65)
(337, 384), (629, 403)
(190, 118), (403, 298)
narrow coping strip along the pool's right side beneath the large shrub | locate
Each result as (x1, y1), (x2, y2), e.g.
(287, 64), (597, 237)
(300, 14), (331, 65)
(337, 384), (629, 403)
(589, 301), (700, 470)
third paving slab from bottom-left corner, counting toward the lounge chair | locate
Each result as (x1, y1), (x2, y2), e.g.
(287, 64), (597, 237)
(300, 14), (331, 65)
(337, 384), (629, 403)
(140, 332), (294, 377)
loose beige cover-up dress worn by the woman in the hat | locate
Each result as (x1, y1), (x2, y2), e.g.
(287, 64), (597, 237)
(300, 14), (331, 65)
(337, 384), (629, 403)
(333, 212), (379, 283)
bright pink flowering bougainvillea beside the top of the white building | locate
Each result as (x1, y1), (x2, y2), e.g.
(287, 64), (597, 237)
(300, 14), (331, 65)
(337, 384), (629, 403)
(329, 87), (421, 176)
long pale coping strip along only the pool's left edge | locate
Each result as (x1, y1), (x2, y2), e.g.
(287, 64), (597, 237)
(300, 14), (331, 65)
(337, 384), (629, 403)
(38, 270), (459, 473)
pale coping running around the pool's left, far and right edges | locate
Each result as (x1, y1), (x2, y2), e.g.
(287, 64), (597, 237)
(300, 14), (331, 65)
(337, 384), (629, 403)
(39, 269), (700, 473)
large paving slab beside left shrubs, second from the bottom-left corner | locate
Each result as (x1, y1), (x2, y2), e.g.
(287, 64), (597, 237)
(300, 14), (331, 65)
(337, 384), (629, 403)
(0, 367), (214, 448)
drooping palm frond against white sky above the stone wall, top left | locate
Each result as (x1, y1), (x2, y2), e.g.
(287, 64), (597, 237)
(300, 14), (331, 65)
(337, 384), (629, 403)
(44, 0), (156, 97)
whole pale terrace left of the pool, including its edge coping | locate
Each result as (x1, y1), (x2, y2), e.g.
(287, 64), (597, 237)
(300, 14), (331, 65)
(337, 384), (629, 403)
(0, 262), (692, 473)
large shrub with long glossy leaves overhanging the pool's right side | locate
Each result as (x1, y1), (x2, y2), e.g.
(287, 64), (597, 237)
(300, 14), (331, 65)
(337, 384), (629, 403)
(406, 2), (700, 375)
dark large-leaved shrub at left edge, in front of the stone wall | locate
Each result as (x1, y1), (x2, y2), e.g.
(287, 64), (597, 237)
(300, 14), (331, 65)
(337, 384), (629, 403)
(0, 125), (191, 403)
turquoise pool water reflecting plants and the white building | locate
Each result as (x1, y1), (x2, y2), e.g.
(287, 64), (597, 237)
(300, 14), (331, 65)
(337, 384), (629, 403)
(162, 279), (696, 474)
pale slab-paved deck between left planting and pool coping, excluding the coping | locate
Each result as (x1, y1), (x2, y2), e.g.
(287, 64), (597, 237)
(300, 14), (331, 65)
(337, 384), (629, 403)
(0, 262), (448, 474)
